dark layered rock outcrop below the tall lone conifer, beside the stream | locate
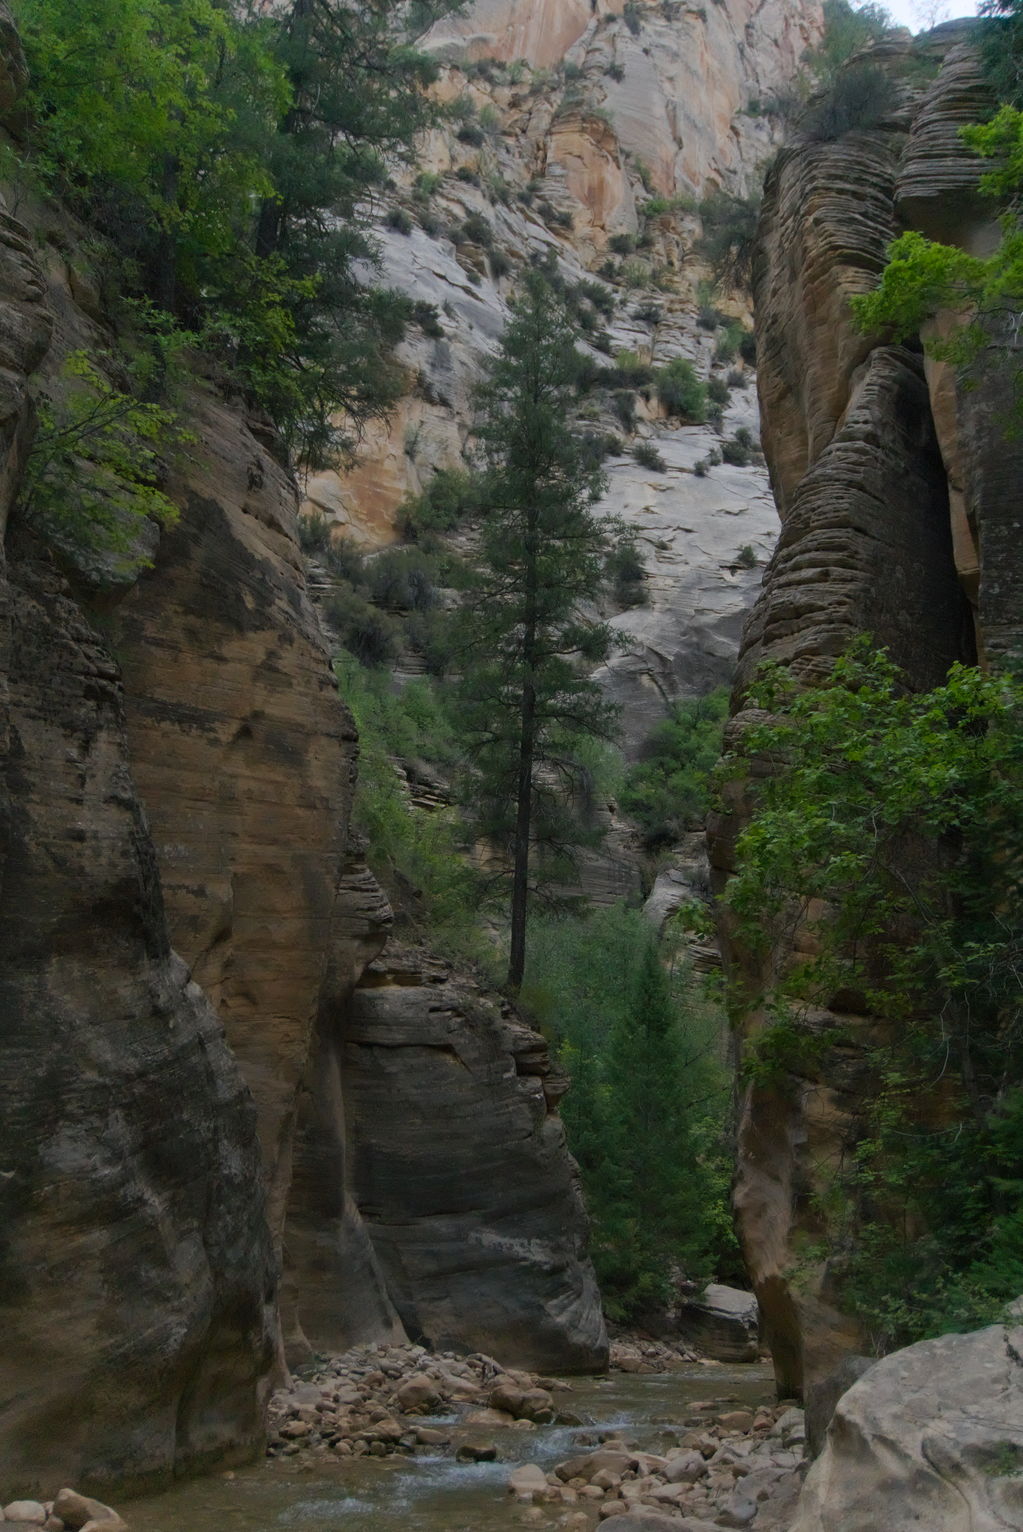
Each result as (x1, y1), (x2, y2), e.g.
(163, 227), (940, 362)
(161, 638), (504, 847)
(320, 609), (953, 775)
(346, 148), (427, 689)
(342, 950), (608, 1373)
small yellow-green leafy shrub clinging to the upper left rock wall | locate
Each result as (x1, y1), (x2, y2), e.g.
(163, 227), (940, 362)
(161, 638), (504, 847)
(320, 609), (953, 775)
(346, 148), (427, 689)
(18, 351), (182, 575)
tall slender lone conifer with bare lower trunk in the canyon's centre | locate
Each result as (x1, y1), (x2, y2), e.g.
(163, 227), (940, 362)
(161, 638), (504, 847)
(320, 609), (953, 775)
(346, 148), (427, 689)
(458, 273), (616, 990)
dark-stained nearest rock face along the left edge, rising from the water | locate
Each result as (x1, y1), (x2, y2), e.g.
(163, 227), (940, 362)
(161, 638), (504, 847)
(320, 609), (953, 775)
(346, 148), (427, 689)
(0, 182), (276, 1495)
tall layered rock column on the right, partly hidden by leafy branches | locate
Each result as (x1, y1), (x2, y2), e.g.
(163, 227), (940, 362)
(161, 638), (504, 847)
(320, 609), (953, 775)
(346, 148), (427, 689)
(711, 25), (1023, 1393)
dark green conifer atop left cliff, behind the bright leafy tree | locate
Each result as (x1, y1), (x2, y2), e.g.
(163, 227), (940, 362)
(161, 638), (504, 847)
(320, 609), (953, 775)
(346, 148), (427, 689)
(241, 0), (452, 463)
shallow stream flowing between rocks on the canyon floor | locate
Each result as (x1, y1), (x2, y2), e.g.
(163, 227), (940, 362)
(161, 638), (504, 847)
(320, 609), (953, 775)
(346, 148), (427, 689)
(121, 1367), (773, 1532)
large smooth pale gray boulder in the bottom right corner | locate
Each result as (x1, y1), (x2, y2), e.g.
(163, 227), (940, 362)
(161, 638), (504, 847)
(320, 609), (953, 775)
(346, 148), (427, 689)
(792, 1325), (1023, 1532)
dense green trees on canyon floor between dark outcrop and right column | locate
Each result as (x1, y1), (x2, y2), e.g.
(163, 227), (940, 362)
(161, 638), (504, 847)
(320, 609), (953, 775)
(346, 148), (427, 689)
(522, 905), (737, 1321)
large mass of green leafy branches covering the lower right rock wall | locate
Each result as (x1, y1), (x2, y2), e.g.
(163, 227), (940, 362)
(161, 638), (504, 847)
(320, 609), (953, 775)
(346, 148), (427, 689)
(726, 642), (1023, 1348)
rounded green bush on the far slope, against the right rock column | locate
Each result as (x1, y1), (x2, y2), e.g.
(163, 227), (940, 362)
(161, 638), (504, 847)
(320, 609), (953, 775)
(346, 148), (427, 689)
(620, 686), (727, 850)
